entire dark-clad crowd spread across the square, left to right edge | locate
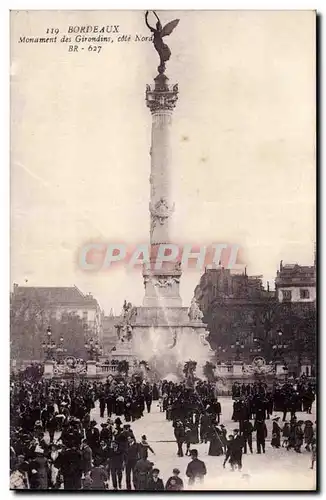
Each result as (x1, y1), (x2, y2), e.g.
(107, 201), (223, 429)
(10, 378), (316, 491)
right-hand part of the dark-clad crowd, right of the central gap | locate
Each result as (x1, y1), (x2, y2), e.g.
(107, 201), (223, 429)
(162, 378), (317, 470)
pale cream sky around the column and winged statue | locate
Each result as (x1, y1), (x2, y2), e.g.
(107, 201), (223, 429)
(11, 11), (316, 313)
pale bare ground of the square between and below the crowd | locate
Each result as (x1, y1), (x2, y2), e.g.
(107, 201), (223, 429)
(91, 397), (316, 490)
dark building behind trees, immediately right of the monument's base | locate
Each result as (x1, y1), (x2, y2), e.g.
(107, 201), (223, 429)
(195, 268), (277, 361)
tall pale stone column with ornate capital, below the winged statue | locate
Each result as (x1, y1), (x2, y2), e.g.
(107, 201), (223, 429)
(143, 73), (182, 307)
